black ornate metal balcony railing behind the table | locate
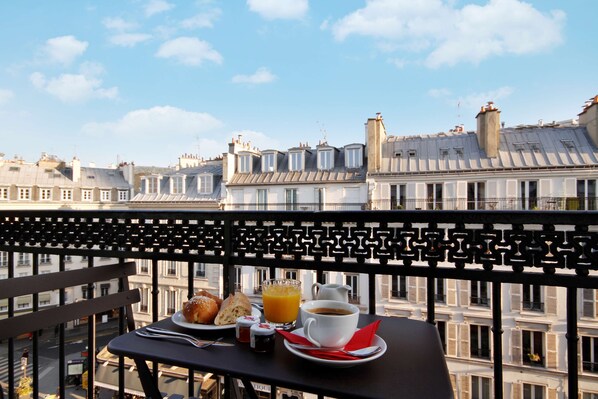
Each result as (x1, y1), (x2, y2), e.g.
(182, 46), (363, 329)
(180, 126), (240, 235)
(0, 209), (598, 398)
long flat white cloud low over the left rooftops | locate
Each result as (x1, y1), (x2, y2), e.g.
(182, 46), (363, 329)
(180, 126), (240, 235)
(82, 106), (223, 139)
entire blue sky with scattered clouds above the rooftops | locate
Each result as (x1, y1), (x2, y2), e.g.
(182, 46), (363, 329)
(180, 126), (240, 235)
(0, 0), (598, 166)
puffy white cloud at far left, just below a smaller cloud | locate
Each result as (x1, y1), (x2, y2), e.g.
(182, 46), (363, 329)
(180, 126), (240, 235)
(29, 67), (118, 103)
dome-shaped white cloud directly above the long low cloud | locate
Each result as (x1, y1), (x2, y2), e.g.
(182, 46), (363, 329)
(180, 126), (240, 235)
(156, 37), (222, 66)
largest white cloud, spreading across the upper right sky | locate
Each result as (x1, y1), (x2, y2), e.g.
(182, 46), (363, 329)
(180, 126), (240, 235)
(332, 0), (565, 68)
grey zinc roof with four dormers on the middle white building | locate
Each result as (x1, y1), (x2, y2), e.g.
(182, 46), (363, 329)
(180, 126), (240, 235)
(228, 147), (366, 186)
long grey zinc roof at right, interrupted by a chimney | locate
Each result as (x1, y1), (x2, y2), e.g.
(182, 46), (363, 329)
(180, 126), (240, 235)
(381, 126), (598, 173)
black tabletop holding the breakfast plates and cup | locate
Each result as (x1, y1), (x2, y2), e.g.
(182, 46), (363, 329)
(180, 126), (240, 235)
(108, 314), (453, 399)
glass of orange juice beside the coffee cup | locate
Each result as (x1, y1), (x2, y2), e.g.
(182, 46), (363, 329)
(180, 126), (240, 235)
(262, 279), (301, 330)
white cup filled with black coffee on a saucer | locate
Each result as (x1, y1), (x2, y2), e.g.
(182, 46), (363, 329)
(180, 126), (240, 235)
(301, 300), (359, 348)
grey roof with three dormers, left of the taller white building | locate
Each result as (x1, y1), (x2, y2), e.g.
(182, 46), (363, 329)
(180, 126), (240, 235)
(131, 161), (222, 202)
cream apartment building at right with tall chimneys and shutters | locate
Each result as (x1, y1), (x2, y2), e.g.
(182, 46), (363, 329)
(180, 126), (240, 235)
(367, 96), (598, 399)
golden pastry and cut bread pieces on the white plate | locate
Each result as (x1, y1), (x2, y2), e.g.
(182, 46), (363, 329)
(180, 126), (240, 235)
(182, 290), (251, 326)
